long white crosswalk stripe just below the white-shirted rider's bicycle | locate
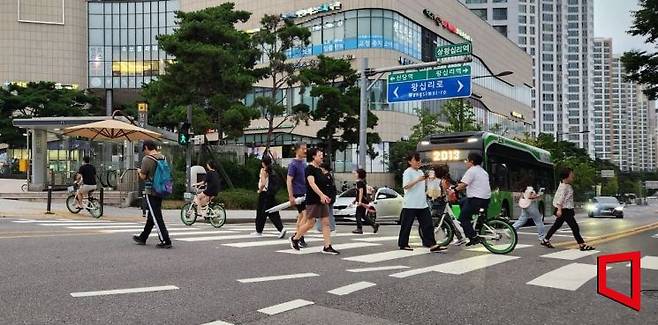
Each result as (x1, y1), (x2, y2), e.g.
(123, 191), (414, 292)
(390, 255), (520, 279)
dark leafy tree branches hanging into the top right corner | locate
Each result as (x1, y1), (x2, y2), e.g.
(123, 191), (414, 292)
(621, 0), (658, 100)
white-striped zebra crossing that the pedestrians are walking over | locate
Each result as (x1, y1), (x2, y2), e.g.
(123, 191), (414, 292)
(12, 219), (658, 293)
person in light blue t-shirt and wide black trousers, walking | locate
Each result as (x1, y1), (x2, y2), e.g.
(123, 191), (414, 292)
(398, 152), (445, 252)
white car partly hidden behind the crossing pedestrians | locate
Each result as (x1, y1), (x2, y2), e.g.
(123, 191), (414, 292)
(334, 187), (404, 223)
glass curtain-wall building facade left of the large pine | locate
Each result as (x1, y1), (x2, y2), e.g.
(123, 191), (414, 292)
(88, 0), (180, 89)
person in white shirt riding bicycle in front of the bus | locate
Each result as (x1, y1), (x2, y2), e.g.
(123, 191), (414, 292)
(456, 152), (491, 246)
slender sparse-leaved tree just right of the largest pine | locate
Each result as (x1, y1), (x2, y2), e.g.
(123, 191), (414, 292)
(251, 15), (311, 150)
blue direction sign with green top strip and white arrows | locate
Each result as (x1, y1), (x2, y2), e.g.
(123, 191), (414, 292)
(386, 65), (471, 103)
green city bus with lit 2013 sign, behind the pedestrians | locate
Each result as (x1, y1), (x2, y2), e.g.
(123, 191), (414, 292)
(417, 131), (555, 219)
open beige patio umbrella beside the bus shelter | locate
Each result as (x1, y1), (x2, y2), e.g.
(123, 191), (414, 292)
(64, 119), (161, 141)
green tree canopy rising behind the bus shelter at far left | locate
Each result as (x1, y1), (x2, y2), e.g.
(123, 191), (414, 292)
(0, 81), (103, 145)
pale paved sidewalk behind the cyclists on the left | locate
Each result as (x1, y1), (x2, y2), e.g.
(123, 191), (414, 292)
(0, 199), (297, 223)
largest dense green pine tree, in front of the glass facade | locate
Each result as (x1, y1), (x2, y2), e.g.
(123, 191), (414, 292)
(142, 3), (261, 137)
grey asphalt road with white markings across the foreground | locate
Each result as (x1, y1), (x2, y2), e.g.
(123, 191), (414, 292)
(0, 206), (658, 324)
